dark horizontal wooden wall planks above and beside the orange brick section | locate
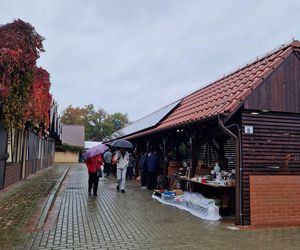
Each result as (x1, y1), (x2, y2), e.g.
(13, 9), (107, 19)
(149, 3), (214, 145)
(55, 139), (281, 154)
(242, 111), (300, 224)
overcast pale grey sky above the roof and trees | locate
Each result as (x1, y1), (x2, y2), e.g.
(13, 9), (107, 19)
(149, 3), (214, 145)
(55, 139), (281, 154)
(0, 0), (300, 121)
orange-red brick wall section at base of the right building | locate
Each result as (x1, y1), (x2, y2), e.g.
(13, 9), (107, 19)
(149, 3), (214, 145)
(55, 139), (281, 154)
(250, 175), (300, 226)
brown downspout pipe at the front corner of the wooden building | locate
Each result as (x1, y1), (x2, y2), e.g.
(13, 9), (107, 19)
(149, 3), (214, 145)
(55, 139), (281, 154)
(218, 115), (243, 225)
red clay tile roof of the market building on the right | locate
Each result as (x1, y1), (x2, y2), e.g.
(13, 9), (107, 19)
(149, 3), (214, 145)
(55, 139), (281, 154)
(127, 41), (300, 138)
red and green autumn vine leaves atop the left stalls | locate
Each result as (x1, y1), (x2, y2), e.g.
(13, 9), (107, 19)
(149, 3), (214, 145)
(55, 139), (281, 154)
(0, 19), (52, 128)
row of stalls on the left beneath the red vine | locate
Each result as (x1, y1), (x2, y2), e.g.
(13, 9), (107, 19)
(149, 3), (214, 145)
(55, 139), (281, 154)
(0, 102), (61, 190)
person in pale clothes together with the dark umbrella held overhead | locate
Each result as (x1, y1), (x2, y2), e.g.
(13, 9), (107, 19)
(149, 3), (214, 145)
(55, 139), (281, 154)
(111, 139), (133, 193)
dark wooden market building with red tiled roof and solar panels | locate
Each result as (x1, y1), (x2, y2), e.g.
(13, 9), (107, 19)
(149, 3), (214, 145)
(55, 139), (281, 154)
(112, 41), (300, 225)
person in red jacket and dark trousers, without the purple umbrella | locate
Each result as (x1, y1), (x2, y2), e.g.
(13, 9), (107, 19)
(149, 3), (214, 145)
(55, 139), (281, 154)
(85, 155), (103, 196)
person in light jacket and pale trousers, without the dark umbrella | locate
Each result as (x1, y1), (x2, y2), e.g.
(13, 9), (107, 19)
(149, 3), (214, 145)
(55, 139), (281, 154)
(115, 148), (129, 193)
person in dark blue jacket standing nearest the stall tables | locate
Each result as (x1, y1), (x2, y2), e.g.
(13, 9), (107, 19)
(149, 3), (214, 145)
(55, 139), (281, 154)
(147, 151), (160, 190)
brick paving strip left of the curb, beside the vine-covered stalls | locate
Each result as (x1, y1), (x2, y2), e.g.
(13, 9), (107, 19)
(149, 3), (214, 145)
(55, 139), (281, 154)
(0, 165), (68, 249)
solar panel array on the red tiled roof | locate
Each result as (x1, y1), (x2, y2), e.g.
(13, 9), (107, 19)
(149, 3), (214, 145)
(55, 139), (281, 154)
(111, 100), (181, 139)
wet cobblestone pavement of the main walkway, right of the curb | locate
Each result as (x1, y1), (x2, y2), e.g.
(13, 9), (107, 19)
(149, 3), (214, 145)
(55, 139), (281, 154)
(0, 165), (300, 250)
